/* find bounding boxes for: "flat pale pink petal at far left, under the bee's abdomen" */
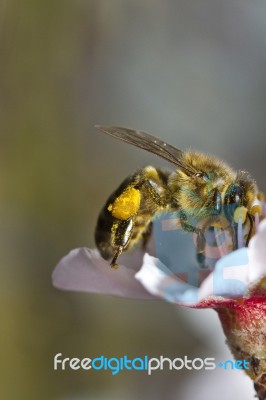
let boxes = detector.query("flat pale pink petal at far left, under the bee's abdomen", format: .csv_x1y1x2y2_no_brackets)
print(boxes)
52,247,154,299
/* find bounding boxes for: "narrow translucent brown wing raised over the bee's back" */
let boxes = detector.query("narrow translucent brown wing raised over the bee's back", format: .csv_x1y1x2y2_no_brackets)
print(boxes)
95,125,195,174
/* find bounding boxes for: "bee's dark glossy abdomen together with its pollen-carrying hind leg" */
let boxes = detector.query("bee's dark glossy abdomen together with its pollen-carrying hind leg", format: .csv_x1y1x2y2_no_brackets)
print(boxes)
95,166,169,265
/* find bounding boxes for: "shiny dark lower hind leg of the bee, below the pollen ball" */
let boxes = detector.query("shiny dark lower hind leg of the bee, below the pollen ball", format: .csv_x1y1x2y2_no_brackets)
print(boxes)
110,218,135,269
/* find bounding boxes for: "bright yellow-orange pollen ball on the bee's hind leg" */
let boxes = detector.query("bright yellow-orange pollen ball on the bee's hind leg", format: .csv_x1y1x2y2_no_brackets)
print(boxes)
108,188,141,220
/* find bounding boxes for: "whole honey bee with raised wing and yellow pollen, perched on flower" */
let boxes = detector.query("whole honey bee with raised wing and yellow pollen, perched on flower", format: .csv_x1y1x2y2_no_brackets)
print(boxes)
95,125,257,268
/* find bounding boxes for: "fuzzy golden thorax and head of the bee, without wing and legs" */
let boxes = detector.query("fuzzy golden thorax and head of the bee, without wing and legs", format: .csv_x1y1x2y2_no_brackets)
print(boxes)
172,151,256,218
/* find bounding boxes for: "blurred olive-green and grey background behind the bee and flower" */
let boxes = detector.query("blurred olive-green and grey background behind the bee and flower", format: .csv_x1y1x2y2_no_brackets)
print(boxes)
0,0,266,400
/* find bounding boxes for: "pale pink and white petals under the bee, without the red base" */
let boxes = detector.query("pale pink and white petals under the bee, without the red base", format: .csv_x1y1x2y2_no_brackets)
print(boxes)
52,216,266,308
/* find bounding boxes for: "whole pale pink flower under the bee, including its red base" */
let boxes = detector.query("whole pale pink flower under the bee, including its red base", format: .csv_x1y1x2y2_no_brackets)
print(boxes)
52,212,266,400
